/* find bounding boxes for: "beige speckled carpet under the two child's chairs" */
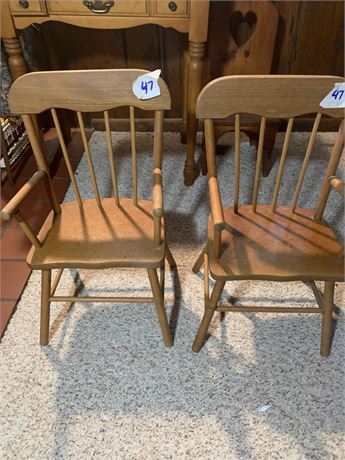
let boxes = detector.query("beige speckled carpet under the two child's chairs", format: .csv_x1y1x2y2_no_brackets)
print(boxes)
0,132,345,460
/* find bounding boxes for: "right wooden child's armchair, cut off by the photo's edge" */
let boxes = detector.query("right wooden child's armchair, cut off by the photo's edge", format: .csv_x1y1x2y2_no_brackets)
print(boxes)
193,76,344,356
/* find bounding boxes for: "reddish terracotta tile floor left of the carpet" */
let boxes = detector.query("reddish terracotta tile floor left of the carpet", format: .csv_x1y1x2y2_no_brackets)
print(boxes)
0,130,84,337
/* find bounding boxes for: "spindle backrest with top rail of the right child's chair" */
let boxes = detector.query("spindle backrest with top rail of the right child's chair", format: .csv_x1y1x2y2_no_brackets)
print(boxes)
196,75,344,220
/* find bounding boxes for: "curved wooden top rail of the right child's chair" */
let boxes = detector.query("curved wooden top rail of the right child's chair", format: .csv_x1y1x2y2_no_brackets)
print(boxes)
196,75,345,119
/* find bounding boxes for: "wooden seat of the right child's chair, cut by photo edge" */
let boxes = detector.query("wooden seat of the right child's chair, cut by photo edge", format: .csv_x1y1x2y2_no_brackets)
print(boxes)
208,205,344,281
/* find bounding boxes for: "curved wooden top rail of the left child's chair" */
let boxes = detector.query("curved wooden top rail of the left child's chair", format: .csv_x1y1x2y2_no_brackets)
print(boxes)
9,69,171,114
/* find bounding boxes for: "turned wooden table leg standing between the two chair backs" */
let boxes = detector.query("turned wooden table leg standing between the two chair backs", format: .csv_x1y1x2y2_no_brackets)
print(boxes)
184,41,205,185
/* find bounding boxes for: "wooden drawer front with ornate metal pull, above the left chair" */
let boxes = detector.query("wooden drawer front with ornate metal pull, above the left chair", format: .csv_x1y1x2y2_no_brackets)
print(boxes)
46,0,147,16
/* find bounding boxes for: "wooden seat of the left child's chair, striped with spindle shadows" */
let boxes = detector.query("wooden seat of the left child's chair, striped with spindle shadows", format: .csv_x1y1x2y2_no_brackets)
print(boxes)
27,198,164,270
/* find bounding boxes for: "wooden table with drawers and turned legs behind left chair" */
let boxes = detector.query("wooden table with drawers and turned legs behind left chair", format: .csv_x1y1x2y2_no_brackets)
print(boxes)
0,0,209,185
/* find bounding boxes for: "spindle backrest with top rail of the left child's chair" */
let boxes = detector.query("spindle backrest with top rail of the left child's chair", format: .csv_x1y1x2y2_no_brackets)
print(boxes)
9,69,171,211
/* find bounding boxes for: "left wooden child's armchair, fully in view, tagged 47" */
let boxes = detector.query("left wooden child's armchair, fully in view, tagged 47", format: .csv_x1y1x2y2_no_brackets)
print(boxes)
1,69,175,346
